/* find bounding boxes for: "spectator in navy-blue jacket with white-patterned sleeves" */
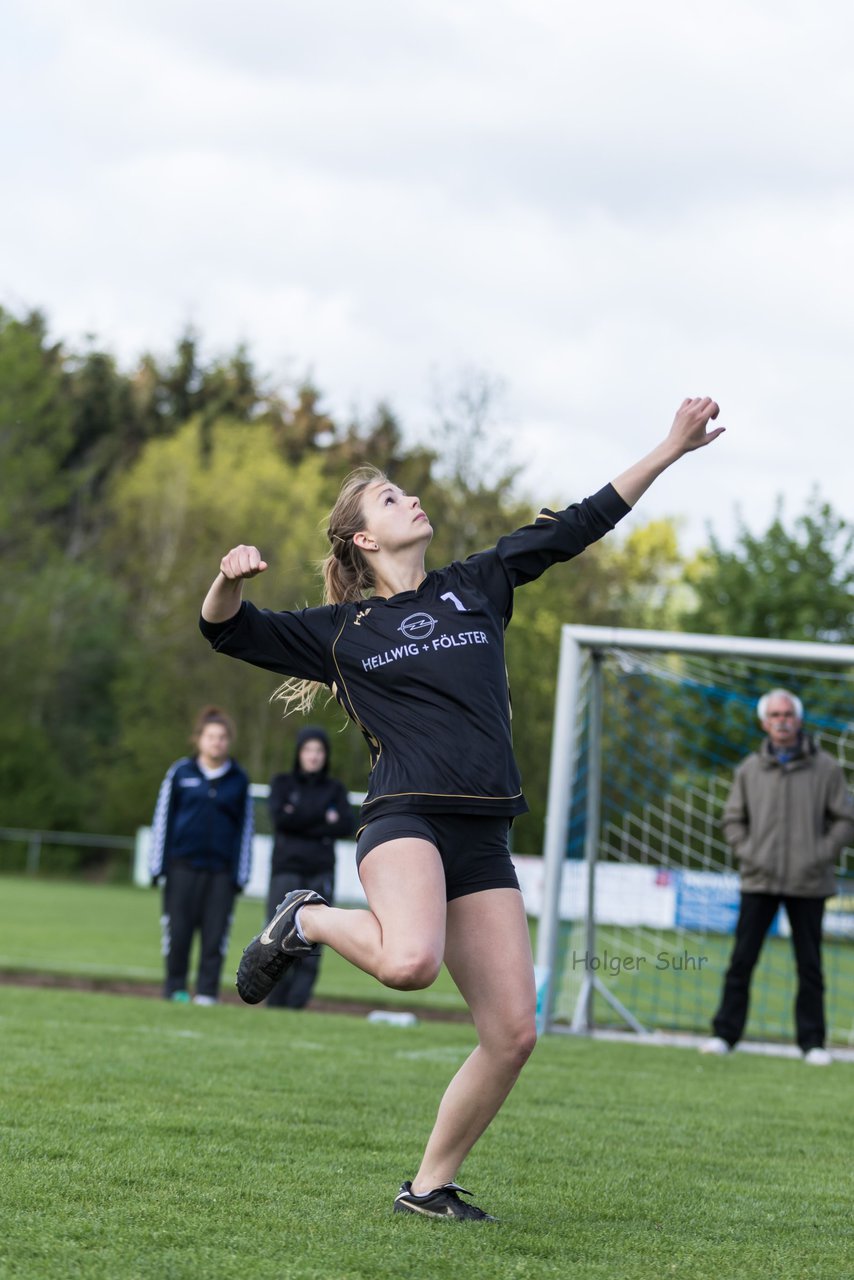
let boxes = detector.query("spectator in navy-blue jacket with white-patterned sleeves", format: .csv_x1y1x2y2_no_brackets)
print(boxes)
149,707,252,1005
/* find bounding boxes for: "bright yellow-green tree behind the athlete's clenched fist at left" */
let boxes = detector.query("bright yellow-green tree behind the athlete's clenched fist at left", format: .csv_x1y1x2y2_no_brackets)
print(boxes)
101,420,364,828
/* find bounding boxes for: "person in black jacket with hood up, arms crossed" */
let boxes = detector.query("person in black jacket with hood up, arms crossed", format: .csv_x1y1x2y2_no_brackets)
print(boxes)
266,727,355,1009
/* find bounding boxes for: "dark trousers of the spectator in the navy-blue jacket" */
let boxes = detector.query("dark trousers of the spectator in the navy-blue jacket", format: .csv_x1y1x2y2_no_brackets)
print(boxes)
160,861,237,998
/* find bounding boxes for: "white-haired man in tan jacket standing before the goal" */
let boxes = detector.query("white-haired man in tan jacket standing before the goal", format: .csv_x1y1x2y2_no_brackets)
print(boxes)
702,689,854,1066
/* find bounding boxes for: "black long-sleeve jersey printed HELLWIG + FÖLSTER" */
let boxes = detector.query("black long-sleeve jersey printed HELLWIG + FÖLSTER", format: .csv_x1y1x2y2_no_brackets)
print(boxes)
200,485,630,823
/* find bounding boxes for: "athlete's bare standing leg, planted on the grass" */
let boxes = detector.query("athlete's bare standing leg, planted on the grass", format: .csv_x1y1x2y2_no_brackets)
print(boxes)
412,888,536,1194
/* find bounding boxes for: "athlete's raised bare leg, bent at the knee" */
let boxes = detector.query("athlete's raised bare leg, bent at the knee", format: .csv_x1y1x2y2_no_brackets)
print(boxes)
300,837,446,991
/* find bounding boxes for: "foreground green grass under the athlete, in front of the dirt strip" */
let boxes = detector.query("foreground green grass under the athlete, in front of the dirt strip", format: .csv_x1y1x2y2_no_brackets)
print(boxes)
0,987,854,1280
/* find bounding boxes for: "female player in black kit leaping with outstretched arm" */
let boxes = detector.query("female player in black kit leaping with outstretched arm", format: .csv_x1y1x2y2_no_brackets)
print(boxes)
201,398,723,1220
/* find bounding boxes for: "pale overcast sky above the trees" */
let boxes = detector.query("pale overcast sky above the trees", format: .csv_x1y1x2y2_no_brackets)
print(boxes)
0,0,854,543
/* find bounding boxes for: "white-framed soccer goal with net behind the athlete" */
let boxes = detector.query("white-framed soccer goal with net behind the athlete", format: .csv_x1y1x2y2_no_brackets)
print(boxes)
536,626,854,1044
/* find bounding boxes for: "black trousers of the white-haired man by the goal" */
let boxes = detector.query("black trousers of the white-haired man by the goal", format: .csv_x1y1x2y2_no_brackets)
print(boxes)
712,893,825,1052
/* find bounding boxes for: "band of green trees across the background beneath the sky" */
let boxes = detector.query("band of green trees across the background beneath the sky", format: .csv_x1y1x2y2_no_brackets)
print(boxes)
0,310,854,870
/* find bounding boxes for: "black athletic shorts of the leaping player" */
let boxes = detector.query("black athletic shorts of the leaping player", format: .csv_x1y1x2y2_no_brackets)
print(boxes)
356,813,519,902
